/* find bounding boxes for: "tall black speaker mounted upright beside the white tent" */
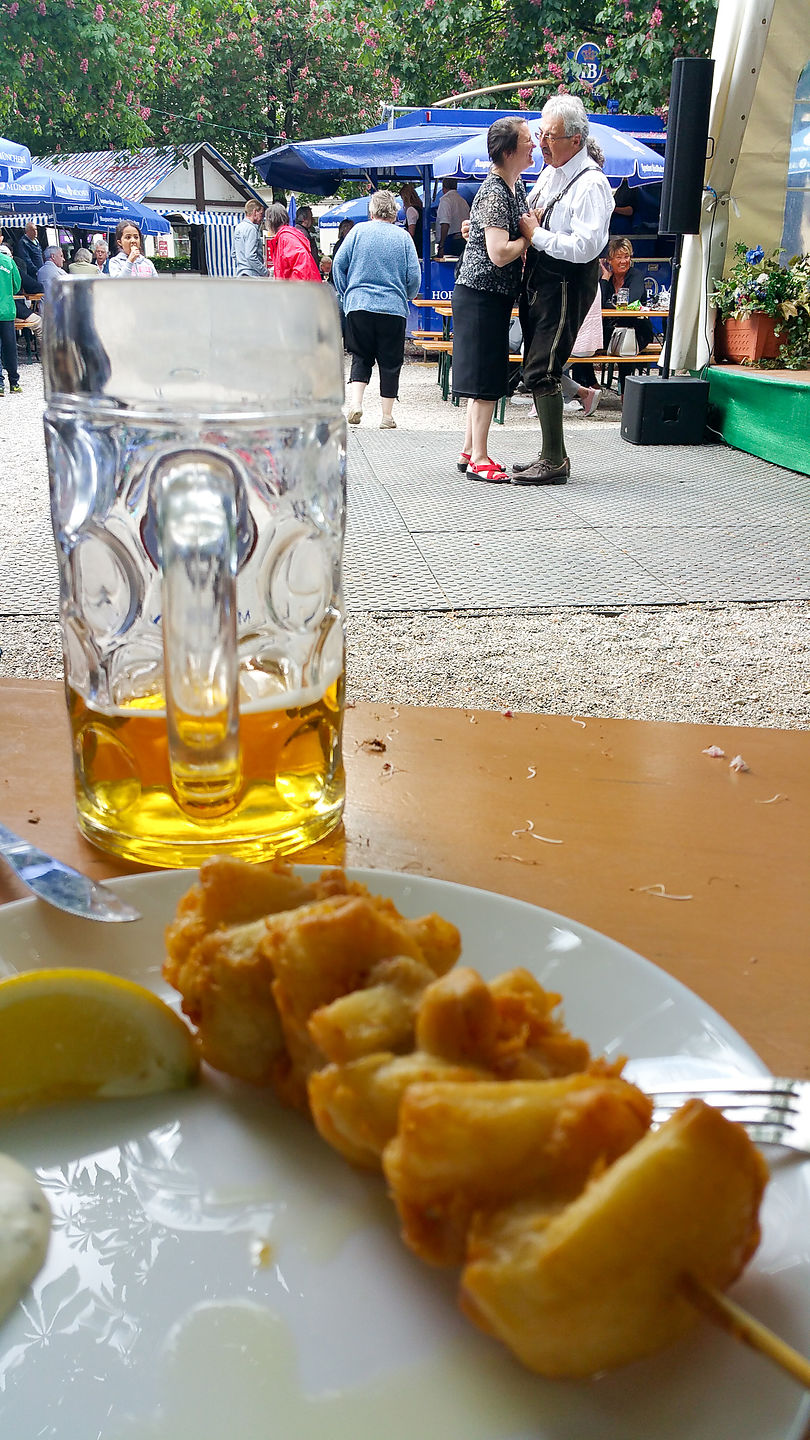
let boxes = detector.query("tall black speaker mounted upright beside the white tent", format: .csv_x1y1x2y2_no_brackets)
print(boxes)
659,59,715,235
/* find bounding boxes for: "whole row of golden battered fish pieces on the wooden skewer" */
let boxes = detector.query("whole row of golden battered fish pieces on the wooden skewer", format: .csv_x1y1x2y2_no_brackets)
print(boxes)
166,861,767,1377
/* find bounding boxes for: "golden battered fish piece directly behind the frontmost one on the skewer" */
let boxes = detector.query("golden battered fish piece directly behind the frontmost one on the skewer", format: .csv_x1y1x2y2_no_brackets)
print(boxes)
382,1073,653,1264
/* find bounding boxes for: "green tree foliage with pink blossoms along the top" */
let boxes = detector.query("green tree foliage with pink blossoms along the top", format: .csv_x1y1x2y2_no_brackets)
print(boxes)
0,0,715,173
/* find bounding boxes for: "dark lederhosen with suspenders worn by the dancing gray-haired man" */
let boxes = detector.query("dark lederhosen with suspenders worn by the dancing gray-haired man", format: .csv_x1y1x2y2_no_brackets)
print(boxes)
517,166,600,395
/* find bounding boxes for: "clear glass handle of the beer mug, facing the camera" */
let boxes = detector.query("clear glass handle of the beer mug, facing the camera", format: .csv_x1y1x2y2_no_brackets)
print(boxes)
153,446,242,821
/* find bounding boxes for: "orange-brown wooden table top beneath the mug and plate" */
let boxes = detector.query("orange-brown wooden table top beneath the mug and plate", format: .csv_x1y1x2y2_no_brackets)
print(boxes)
0,680,810,1076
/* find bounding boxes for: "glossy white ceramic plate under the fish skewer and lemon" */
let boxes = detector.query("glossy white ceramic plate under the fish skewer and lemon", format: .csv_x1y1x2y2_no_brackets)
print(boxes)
0,871,810,1440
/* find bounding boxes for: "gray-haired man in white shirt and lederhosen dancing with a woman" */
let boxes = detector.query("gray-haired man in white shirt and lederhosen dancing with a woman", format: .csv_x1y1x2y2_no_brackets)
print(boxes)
512,95,613,485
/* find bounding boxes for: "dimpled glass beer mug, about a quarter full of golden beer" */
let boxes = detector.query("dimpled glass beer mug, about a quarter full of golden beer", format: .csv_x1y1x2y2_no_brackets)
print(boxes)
45,278,346,865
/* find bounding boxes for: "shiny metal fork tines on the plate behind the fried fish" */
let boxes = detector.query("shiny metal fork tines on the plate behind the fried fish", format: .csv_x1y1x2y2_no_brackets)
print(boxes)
647,1076,810,1155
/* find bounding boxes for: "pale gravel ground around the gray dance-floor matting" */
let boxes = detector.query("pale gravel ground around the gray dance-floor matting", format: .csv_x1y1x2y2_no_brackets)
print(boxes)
0,349,810,729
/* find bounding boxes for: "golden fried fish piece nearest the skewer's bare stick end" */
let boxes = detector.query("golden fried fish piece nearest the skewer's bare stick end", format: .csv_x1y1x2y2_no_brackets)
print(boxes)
461,1100,768,1378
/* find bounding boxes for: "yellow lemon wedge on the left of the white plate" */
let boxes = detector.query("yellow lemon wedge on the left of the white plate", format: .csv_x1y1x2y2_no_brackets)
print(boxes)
0,969,199,1110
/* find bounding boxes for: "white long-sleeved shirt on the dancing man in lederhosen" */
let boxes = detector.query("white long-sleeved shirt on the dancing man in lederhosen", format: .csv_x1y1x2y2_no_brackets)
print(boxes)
529,150,613,265
